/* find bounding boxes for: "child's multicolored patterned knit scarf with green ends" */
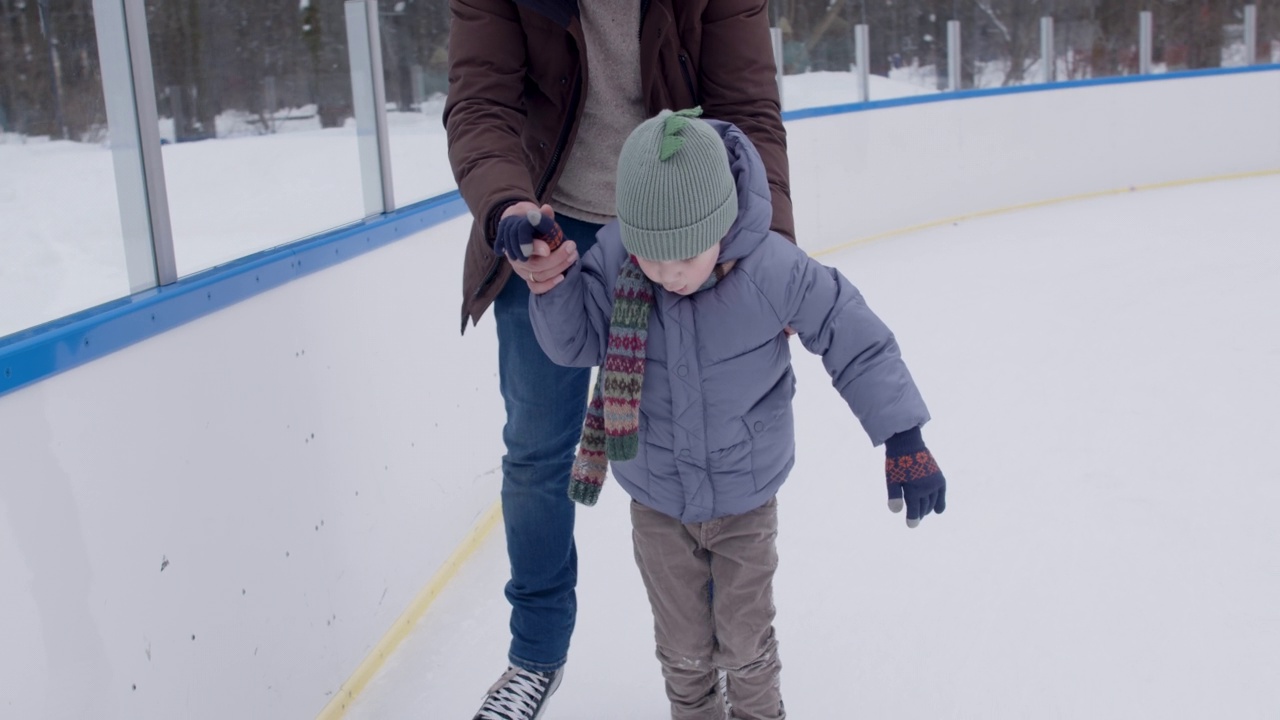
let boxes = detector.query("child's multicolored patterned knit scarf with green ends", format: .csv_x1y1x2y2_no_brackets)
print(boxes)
568,258,733,505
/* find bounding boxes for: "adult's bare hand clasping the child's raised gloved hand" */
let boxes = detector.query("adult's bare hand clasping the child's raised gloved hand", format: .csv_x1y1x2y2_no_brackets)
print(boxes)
493,201,577,295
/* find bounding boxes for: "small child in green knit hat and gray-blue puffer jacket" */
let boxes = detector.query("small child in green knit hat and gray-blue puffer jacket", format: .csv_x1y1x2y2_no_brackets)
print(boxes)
497,109,946,720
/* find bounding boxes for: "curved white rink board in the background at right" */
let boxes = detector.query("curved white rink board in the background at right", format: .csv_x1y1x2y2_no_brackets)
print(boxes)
787,72,1280,250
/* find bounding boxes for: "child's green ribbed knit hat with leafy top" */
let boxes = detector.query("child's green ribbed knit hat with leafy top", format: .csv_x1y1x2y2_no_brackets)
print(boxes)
617,108,737,261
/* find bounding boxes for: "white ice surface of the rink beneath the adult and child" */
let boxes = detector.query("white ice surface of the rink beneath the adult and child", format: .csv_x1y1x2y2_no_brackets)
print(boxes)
347,176,1280,720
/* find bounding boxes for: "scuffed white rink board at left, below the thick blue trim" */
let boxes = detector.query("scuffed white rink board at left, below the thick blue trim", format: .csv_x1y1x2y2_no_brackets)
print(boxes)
0,212,503,720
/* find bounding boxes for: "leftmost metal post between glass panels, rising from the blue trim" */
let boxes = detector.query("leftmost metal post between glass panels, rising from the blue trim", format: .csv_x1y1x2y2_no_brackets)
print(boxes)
93,0,178,292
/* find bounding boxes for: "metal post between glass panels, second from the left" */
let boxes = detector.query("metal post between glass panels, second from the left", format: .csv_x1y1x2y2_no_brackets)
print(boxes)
344,0,396,217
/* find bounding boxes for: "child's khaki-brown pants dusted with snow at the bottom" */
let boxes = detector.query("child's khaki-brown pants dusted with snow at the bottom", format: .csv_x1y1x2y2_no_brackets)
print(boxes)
631,500,786,720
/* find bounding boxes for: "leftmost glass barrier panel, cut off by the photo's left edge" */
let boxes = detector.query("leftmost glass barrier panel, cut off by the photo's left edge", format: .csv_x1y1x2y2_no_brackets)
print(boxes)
0,0,129,337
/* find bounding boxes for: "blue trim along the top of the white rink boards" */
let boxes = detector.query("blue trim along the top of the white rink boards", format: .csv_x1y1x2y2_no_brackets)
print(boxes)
0,64,1280,396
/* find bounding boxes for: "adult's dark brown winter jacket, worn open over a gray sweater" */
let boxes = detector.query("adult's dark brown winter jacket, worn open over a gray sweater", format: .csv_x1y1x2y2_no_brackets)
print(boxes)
444,0,795,331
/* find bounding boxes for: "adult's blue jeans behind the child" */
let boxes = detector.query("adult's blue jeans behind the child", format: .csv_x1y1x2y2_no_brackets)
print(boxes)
493,211,600,671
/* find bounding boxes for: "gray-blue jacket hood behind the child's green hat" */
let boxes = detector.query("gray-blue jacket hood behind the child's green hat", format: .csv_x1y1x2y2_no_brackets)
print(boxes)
704,118,773,263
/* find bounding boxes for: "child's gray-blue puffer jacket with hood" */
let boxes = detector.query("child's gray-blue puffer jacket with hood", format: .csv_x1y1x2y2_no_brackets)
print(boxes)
529,120,929,523
